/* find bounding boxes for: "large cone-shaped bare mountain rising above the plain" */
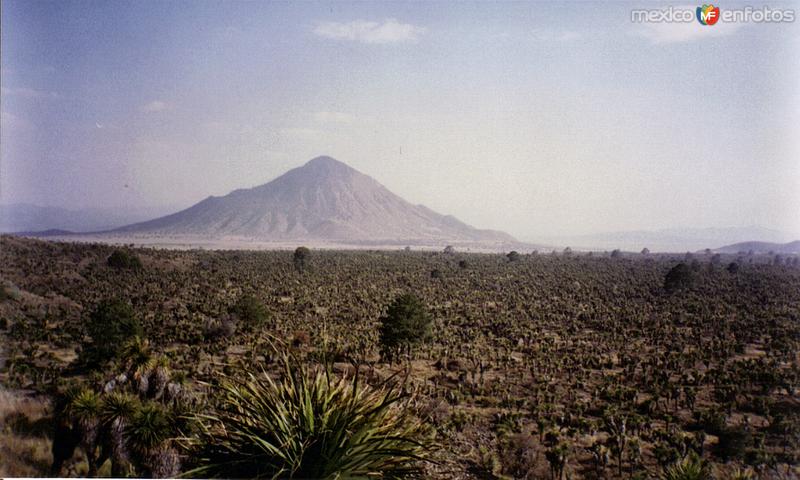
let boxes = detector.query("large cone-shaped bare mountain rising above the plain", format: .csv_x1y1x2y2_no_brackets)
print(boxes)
108,156,515,244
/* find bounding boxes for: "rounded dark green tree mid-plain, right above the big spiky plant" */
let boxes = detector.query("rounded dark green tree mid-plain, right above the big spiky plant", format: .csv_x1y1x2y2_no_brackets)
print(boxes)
380,293,431,361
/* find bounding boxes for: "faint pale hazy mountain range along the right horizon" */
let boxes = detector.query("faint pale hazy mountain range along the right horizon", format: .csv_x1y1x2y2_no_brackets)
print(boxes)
547,226,793,252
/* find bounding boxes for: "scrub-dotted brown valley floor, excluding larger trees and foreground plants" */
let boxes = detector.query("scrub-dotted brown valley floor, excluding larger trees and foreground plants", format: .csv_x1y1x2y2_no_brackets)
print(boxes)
0,236,800,479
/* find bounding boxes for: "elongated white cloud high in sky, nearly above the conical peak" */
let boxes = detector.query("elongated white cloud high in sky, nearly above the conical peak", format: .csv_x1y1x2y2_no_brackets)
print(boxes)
314,18,425,44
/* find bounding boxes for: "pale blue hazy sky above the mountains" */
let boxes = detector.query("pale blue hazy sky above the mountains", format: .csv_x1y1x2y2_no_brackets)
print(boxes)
0,0,800,239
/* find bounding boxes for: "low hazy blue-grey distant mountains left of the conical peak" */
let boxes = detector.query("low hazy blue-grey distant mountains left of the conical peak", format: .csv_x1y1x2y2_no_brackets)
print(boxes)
0,203,176,233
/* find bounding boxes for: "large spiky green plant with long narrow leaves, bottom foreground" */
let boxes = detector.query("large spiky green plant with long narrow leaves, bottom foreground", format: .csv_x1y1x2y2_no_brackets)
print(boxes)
187,358,431,478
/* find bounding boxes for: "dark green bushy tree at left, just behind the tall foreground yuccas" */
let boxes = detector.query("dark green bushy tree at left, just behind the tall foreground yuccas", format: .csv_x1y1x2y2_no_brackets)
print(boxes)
83,299,142,364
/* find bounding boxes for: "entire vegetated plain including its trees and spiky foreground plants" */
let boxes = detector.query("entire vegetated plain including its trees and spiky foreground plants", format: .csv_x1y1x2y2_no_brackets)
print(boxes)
0,237,800,479
